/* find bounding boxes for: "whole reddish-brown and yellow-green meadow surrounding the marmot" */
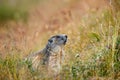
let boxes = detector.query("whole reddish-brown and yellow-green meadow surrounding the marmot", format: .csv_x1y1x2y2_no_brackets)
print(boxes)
0,0,120,80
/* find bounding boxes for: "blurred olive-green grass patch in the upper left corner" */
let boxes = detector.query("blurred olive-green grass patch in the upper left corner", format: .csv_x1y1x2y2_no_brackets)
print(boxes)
0,0,42,22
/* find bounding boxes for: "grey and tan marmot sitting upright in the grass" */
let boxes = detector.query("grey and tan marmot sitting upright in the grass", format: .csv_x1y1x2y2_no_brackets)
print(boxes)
27,34,67,75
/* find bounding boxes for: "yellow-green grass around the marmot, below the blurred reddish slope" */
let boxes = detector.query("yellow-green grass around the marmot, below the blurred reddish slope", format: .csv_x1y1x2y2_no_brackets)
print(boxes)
0,0,120,80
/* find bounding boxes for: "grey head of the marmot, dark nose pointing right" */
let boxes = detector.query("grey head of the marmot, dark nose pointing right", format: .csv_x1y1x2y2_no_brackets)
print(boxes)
47,34,67,49
